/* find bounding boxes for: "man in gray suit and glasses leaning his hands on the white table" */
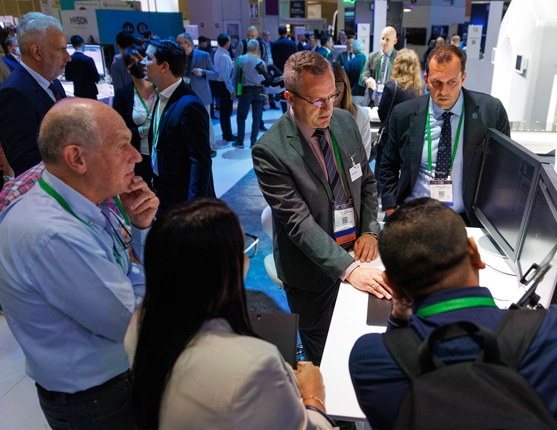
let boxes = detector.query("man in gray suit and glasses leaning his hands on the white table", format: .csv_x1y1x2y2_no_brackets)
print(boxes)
252,51,391,365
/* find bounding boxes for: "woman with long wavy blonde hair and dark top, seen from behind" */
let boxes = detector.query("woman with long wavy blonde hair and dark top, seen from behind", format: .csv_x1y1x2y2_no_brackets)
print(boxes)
375,48,424,187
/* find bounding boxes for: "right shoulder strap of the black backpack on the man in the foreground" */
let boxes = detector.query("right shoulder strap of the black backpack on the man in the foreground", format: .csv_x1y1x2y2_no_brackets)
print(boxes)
495,309,545,370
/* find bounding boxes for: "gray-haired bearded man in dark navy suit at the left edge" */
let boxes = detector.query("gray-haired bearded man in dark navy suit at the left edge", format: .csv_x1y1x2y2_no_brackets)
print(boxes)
0,12,71,176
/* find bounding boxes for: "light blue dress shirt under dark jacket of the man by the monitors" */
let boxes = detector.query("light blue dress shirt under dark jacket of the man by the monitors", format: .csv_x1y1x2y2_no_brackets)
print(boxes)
405,90,464,213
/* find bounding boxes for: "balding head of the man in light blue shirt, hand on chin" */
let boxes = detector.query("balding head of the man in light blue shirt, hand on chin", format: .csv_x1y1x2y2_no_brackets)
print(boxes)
39,98,141,204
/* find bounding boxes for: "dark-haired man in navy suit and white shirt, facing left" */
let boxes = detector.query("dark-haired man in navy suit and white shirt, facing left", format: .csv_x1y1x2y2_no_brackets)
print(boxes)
143,40,215,210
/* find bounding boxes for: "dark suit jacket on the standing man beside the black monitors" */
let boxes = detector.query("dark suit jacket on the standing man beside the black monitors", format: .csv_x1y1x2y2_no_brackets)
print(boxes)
379,88,510,226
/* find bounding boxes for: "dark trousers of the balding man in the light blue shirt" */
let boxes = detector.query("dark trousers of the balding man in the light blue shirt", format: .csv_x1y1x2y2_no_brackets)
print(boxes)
35,371,137,430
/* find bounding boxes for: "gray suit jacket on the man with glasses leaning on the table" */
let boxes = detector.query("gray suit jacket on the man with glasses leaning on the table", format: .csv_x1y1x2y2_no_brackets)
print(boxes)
252,108,379,292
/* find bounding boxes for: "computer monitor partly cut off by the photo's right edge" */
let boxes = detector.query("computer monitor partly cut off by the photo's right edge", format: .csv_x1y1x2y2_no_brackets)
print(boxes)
517,163,557,308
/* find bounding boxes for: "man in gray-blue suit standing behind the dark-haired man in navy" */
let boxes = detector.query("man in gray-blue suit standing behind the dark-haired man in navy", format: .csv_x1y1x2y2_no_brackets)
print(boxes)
176,33,219,157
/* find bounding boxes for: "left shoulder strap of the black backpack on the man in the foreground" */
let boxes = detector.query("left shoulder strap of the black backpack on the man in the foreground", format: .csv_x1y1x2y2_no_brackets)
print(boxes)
381,327,422,379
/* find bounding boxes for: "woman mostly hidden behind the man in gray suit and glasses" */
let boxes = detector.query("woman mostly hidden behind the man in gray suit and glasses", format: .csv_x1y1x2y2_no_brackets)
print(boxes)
333,63,371,161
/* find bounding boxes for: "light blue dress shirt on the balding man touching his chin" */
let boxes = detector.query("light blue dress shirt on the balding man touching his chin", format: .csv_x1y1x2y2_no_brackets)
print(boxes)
0,170,147,393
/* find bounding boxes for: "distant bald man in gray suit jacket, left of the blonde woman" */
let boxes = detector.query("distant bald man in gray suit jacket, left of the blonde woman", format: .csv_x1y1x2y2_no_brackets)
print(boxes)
362,27,397,107
